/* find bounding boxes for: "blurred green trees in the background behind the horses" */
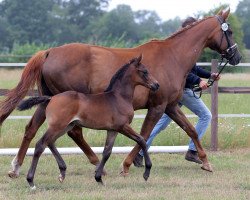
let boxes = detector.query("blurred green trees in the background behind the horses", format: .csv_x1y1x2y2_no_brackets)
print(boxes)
0,0,250,62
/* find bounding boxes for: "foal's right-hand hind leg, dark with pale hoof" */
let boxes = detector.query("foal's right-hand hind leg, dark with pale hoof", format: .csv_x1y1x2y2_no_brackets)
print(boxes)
48,143,67,183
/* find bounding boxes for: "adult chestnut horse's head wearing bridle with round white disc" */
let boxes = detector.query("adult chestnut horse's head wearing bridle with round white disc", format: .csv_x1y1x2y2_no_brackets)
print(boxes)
207,9,241,65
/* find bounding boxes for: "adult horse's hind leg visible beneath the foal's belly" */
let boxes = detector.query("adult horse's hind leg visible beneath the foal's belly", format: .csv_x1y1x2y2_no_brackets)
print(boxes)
68,126,100,166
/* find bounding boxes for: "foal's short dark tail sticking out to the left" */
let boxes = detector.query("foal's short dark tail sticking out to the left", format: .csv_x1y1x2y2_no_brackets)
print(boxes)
17,96,51,111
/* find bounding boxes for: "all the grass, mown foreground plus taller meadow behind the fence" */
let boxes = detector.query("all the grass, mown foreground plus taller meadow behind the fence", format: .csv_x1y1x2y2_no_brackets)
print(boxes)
0,69,250,200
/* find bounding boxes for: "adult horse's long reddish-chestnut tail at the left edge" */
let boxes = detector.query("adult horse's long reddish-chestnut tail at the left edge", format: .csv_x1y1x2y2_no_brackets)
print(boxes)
0,51,49,125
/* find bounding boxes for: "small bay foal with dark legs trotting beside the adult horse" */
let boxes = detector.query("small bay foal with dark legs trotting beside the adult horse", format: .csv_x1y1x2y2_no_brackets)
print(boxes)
18,56,159,189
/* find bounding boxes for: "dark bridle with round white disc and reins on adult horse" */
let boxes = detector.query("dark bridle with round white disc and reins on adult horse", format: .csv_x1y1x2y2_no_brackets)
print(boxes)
192,15,234,99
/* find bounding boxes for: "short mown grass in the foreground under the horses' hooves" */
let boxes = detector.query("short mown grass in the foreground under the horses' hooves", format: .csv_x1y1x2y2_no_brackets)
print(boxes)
0,148,250,200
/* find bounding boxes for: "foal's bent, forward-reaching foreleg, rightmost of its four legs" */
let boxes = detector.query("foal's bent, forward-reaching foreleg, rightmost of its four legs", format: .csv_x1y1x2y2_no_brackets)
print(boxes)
121,124,152,180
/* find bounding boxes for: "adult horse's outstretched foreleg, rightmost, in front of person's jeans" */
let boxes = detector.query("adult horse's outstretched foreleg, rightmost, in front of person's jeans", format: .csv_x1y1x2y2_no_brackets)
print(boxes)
165,106,213,172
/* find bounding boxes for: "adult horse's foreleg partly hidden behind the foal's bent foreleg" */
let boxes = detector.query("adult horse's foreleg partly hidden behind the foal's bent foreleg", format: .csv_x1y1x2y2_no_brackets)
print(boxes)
121,105,165,175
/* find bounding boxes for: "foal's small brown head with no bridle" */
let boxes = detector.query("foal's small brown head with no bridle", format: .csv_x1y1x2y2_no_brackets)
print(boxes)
131,55,160,91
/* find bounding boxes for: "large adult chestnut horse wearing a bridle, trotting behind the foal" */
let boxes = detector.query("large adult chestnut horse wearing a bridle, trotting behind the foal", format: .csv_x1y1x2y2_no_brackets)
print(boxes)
0,9,241,177
